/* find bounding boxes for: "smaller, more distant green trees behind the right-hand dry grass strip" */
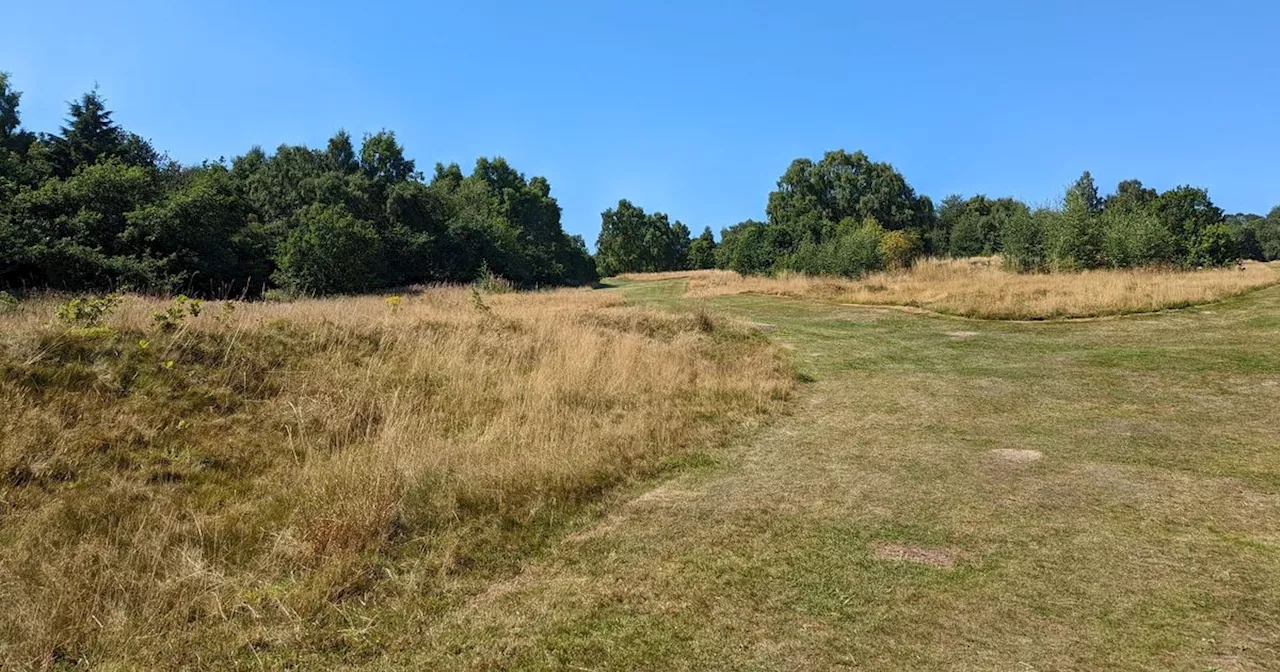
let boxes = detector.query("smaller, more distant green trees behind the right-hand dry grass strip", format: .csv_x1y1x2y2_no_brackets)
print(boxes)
596,150,1280,276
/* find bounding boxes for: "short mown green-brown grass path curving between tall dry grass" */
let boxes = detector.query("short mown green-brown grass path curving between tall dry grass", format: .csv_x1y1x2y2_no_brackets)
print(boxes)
378,276,1280,671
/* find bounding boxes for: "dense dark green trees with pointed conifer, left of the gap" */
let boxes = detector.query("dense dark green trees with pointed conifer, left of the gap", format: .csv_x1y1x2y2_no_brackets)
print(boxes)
0,73,598,296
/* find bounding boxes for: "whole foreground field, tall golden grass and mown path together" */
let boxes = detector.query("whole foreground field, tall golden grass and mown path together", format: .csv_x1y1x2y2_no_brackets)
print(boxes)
0,269,1280,672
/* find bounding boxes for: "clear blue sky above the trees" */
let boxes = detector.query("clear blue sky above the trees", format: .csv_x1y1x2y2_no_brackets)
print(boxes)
0,0,1280,243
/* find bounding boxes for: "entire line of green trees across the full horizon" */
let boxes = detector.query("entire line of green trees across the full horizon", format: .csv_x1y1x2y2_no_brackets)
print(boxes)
0,73,1280,296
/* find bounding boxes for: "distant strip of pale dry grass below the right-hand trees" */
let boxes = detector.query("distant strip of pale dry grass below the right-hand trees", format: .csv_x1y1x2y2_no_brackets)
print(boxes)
623,257,1280,320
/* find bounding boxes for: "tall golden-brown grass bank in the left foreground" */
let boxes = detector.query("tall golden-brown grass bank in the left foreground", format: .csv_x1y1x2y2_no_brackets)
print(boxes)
0,288,792,667
